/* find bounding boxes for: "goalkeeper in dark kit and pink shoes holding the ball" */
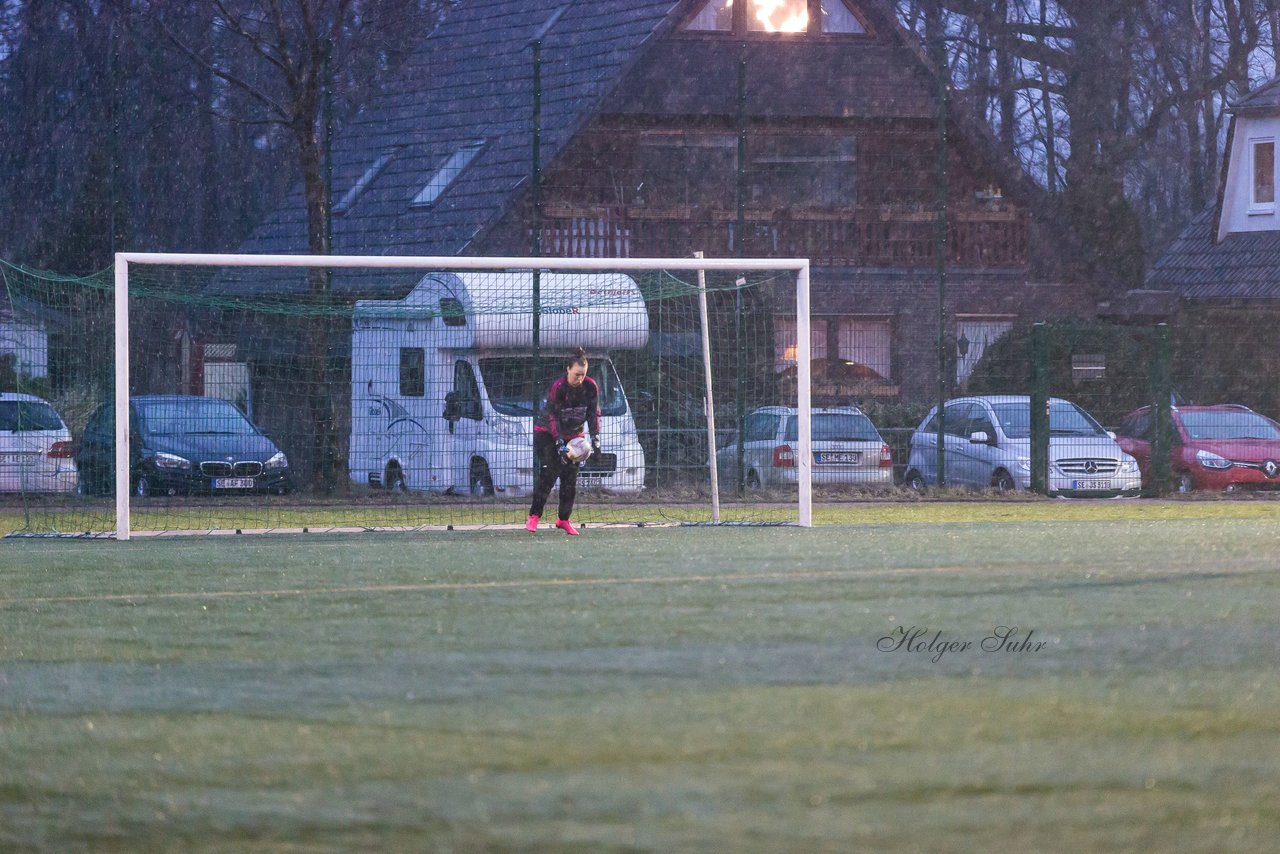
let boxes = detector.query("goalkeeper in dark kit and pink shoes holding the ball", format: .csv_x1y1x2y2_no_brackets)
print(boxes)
525,347,600,536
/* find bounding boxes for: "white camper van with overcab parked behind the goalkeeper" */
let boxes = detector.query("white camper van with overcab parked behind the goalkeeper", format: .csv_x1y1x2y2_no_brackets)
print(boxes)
348,270,649,497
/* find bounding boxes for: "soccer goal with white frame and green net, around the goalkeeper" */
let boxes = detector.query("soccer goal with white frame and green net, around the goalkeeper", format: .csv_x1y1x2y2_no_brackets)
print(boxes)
2,252,812,539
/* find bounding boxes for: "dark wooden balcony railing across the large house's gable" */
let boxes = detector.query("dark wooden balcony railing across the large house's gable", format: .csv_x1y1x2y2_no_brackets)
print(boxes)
541,205,1027,266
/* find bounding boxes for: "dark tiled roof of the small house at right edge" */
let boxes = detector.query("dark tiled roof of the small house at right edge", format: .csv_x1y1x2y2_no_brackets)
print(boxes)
1146,206,1280,300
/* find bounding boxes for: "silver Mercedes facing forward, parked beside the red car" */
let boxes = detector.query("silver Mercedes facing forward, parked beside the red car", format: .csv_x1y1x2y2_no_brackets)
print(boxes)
904,394,1142,498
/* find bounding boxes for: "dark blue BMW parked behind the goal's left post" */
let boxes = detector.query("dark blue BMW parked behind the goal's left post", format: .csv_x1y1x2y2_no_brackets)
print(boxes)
76,394,291,497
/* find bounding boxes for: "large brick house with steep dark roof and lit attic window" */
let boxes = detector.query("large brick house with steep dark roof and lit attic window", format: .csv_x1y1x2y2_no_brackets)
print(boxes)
218,0,1098,417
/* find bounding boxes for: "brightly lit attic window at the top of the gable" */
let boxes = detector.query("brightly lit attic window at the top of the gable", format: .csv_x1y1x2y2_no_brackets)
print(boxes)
685,0,868,36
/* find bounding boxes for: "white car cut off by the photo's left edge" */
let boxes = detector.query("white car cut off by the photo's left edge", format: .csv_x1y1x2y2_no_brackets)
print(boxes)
0,392,77,493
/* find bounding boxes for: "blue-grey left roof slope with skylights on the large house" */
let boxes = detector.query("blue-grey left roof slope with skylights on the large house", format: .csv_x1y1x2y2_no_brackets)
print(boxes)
214,0,678,293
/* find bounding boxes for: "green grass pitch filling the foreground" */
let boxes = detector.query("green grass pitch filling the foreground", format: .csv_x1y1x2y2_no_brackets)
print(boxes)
0,502,1280,853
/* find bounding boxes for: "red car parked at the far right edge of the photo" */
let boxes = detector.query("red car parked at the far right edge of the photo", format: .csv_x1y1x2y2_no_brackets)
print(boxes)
1116,403,1280,492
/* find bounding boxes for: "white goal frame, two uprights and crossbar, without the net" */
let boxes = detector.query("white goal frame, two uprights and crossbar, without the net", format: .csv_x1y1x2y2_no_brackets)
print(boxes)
114,252,813,540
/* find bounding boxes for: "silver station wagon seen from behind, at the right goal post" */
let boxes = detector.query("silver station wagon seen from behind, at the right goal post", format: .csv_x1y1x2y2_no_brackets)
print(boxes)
716,406,893,488
